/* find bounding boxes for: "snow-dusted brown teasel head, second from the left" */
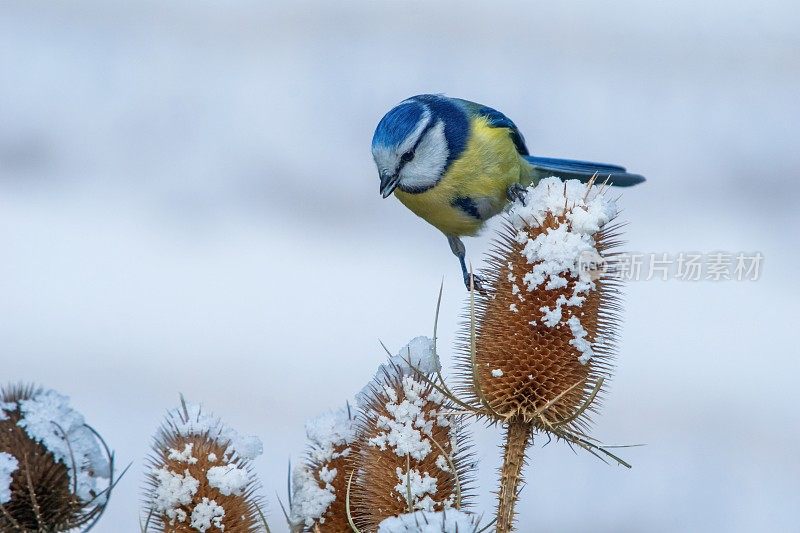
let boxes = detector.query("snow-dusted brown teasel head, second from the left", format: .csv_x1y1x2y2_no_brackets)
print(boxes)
143,399,266,533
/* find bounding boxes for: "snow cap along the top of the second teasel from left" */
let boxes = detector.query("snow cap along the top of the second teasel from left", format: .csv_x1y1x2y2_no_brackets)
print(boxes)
168,403,264,461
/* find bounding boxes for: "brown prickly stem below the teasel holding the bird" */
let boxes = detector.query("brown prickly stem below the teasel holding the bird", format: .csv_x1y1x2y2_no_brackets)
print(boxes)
496,418,533,533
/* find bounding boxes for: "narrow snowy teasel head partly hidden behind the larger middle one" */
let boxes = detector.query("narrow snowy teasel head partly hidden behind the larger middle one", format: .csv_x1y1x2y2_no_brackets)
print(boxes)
290,405,358,533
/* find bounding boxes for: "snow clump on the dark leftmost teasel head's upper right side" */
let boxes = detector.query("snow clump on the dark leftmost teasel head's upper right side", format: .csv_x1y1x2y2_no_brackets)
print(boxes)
17,390,110,502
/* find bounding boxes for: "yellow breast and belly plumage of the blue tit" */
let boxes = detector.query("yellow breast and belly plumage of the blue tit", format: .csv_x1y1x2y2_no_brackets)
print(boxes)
395,117,526,236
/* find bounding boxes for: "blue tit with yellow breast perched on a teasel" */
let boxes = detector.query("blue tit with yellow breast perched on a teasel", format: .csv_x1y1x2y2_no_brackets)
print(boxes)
372,94,645,290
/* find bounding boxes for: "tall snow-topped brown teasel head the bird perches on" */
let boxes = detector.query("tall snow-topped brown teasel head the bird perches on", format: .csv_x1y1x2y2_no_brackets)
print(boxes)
461,178,619,431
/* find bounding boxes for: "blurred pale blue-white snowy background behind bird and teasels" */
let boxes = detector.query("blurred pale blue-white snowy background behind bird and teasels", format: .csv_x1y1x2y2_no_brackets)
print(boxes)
0,0,800,532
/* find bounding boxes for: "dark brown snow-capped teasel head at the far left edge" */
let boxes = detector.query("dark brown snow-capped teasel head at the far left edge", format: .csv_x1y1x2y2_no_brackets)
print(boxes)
0,385,114,531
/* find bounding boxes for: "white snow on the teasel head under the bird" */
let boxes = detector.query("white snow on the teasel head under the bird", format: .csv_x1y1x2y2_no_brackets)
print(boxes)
509,177,618,364
